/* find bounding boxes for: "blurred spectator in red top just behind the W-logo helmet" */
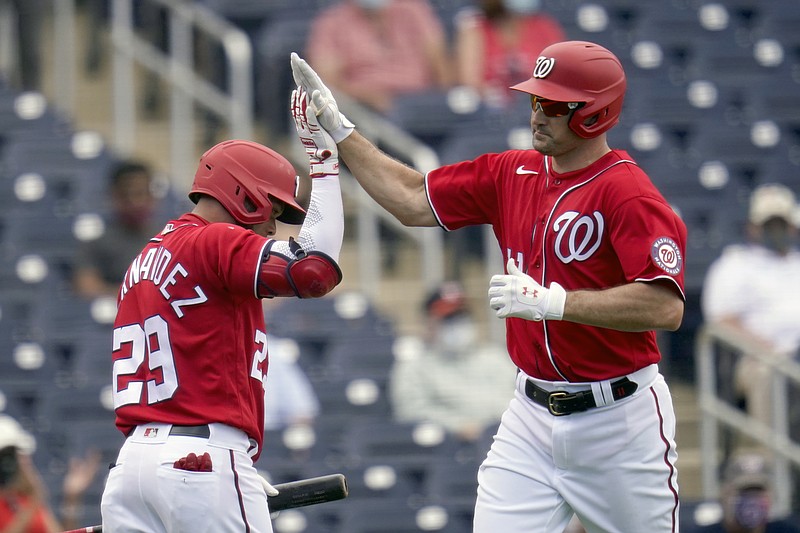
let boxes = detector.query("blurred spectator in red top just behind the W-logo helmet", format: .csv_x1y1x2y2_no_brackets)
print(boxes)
454,0,565,107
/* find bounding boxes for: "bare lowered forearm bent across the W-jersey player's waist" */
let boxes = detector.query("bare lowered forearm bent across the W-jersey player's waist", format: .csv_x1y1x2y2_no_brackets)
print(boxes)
563,282,684,331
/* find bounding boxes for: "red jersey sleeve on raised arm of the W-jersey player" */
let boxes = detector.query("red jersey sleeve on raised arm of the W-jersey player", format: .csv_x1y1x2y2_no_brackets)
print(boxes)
425,154,500,231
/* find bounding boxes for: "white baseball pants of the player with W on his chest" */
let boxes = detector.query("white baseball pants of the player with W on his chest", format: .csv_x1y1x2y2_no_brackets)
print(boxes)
473,365,679,533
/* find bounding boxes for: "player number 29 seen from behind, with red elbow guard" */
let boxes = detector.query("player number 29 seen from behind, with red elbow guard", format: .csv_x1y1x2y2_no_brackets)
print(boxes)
102,90,344,533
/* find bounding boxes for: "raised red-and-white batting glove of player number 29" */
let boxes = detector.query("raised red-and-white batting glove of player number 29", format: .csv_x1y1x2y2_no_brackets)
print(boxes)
291,87,339,178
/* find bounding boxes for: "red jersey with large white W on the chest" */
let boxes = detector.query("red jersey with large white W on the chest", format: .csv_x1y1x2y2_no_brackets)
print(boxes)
426,150,686,382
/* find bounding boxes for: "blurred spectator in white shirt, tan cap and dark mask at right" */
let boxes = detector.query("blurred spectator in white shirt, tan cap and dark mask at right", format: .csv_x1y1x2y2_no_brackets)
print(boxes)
702,184,800,424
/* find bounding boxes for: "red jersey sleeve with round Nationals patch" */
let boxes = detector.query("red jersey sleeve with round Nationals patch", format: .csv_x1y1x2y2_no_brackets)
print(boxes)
610,196,686,298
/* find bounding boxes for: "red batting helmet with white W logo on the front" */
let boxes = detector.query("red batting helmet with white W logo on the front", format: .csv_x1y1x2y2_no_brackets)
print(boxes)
511,41,626,139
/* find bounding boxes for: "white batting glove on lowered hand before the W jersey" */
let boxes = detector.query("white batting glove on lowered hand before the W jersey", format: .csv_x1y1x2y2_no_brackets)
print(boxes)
489,259,567,322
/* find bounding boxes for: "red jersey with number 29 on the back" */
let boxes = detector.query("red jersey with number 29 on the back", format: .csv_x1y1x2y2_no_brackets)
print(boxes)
113,214,269,458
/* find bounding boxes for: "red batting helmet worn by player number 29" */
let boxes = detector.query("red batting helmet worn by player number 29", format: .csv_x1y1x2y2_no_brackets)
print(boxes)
189,140,306,225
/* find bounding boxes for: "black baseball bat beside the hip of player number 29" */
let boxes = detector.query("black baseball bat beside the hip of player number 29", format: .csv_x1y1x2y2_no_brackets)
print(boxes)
63,474,349,533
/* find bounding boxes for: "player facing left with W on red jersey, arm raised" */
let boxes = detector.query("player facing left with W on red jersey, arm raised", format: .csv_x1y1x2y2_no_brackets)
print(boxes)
291,41,686,533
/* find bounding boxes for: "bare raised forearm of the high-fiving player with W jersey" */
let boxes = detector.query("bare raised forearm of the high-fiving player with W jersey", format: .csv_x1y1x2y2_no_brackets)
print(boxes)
338,131,437,226
